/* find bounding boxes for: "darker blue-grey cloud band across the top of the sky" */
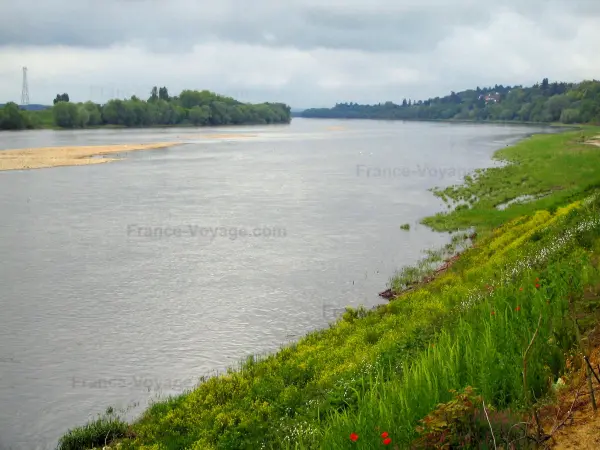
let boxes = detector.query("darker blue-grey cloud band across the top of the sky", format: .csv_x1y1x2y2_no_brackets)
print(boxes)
0,0,600,52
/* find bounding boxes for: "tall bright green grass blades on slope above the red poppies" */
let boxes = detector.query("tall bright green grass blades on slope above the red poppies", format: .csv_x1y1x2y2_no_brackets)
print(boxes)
308,253,599,449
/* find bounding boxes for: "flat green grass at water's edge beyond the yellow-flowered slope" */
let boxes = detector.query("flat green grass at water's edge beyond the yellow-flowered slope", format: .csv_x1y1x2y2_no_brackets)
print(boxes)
422,127,600,231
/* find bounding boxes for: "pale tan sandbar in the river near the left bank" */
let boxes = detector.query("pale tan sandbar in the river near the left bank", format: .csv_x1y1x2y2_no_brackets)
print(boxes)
0,142,182,170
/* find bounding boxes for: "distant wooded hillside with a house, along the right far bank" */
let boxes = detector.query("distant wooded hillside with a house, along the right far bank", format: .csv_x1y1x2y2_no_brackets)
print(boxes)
298,78,600,124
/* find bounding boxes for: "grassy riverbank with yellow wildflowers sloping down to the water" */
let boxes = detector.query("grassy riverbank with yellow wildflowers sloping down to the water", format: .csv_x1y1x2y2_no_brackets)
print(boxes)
60,128,600,450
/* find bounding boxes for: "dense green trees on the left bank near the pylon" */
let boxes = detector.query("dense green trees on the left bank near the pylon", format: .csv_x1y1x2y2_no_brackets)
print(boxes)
0,87,291,130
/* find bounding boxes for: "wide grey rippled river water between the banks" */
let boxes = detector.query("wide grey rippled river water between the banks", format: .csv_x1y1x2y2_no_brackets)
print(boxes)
0,119,542,450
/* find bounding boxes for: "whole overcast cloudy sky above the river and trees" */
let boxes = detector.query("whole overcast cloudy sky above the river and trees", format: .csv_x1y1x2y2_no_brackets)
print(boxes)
0,0,600,108
